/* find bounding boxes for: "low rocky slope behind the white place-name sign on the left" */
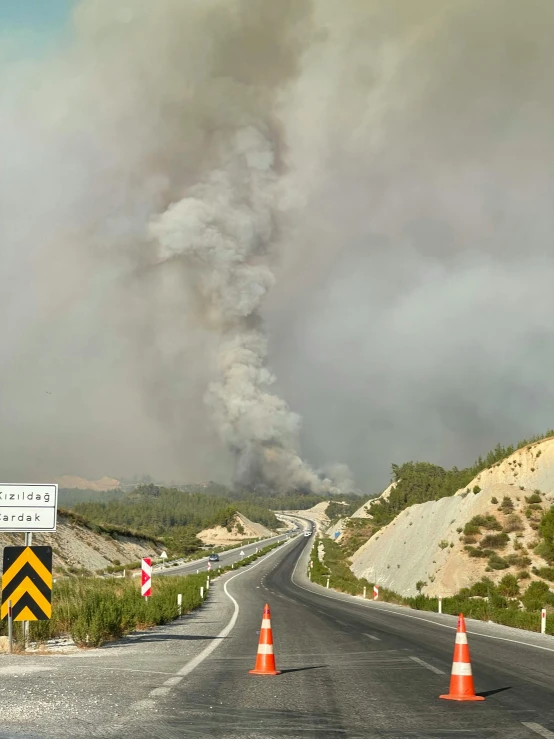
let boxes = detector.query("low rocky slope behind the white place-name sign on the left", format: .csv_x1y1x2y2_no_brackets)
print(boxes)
0,513,162,574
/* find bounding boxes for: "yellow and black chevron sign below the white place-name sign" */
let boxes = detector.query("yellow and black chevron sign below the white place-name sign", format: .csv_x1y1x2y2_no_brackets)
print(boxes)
0,547,52,621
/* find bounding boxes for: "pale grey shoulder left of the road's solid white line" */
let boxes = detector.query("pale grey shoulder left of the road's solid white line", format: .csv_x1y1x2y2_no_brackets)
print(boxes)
0,568,235,739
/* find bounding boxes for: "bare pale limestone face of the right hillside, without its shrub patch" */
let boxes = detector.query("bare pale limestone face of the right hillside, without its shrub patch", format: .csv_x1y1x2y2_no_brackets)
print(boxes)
352,438,554,596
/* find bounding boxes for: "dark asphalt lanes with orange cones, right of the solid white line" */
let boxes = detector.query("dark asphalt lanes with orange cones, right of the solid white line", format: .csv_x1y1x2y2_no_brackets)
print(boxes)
137,537,554,739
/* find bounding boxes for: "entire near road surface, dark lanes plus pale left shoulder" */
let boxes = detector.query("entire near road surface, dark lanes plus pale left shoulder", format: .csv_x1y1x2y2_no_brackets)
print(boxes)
0,536,554,739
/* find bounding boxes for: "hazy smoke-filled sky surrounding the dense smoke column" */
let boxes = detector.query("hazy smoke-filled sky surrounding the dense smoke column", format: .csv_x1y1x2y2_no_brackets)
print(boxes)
0,0,554,492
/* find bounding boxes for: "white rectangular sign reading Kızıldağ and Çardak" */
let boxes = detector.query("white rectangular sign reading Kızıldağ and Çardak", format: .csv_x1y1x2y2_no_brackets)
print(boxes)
0,483,58,531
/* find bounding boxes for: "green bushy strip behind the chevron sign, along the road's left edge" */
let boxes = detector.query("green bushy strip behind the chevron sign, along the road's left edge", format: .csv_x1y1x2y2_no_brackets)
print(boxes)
0,542,283,647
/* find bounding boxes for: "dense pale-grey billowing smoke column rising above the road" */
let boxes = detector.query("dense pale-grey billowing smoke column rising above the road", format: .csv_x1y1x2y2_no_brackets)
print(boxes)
150,126,330,491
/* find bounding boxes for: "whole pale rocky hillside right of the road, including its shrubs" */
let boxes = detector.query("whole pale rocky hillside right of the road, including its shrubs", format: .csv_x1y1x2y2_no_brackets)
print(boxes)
352,438,554,596
